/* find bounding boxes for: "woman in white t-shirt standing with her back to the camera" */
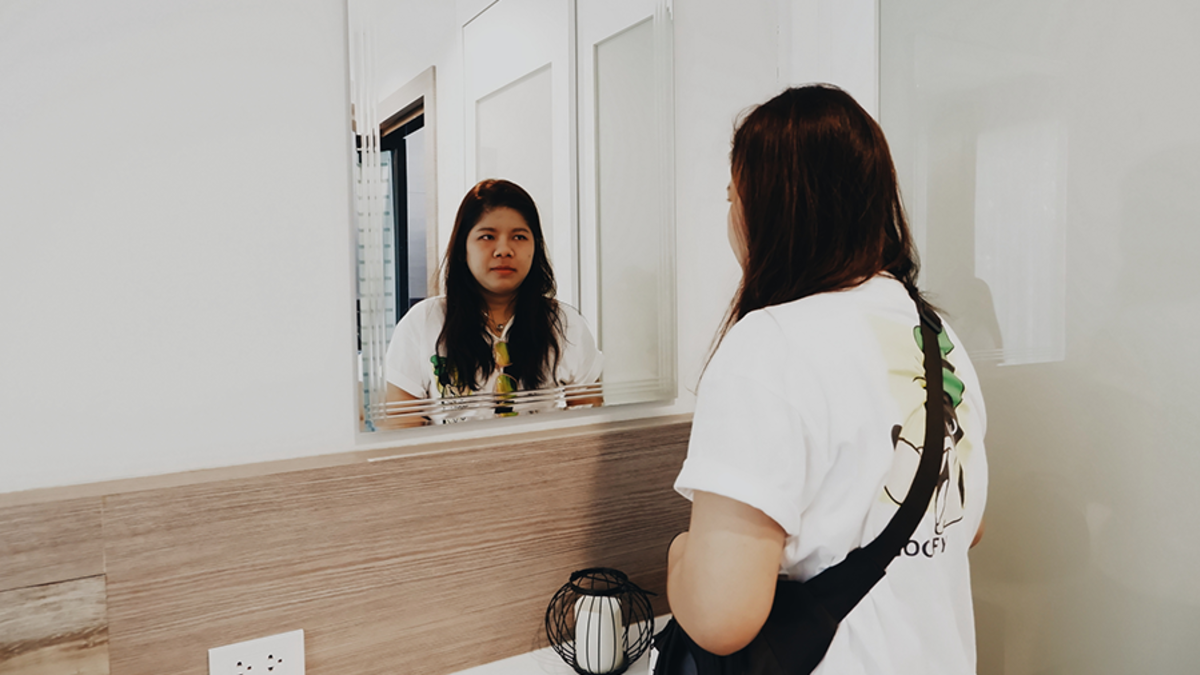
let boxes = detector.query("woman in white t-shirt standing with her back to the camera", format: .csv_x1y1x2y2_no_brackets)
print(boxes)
667,85,988,675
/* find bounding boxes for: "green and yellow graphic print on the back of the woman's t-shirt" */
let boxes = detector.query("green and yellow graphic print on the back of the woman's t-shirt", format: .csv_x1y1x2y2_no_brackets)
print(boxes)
883,325,966,536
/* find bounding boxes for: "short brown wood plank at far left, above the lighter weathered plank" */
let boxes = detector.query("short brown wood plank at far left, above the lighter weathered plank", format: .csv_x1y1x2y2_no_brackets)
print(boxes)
0,497,104,591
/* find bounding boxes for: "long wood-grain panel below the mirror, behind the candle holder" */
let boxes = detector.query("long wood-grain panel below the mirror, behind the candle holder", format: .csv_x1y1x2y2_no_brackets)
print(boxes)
0,422,690,675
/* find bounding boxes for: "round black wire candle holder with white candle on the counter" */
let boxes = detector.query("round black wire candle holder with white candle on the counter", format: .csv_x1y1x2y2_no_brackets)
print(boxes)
546,567,654,675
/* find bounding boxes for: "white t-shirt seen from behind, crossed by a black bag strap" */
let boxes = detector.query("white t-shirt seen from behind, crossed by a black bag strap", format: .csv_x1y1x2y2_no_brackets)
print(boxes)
676,276,988,675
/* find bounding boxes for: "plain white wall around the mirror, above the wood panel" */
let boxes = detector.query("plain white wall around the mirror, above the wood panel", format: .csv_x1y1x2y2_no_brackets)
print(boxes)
0,0,874,494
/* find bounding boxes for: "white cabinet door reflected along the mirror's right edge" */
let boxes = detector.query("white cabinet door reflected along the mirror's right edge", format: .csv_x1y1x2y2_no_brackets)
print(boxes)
577,0,674,402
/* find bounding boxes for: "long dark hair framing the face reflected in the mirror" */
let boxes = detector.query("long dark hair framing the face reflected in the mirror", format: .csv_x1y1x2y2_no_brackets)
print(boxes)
438,179,563,390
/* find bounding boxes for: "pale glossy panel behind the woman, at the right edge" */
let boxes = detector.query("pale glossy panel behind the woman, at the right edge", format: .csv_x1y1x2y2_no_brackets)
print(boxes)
880,0,1200,675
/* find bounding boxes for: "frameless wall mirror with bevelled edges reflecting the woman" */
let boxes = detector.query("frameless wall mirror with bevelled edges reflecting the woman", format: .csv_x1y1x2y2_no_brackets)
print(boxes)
349,0,676,431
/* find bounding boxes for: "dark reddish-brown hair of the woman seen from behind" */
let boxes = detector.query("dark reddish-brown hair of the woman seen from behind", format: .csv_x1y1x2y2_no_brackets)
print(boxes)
716,84,924,342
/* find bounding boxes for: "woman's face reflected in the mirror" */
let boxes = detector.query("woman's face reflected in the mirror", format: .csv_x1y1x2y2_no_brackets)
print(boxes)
467,207,535,298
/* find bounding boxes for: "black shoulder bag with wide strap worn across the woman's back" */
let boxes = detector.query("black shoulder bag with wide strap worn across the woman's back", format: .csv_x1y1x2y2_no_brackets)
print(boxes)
653,301,946,675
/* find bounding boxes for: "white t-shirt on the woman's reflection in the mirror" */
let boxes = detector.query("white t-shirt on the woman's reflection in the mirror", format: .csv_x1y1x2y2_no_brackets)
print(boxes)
386,295,604,423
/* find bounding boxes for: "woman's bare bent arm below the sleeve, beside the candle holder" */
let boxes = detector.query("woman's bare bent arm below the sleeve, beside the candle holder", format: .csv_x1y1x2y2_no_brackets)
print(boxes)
667,491,787,655
